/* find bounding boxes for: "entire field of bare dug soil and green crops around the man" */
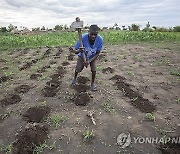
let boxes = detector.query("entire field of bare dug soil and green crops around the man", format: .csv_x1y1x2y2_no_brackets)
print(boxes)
0,31,180,154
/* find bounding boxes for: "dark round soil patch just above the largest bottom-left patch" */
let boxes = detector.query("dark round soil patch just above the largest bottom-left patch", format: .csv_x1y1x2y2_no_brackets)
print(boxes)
23,106,51,122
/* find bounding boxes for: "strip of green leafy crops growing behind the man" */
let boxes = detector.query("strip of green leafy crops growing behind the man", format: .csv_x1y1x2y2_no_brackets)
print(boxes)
0,30,180,50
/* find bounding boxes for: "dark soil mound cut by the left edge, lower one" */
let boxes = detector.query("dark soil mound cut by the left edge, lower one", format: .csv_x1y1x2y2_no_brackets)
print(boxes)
0,94,21,106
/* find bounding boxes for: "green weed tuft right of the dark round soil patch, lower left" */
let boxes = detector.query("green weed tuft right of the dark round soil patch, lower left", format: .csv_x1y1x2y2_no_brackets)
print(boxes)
47,114,67,128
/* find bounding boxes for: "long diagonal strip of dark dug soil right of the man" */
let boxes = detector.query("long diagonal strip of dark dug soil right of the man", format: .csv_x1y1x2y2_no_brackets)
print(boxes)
110,76,156,113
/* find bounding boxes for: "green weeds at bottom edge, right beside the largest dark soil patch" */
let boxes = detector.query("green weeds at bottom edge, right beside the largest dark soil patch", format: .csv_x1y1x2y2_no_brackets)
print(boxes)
33,142,56,154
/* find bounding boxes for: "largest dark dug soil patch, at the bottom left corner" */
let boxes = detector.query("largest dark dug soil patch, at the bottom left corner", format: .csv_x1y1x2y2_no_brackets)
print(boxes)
13,123,49,154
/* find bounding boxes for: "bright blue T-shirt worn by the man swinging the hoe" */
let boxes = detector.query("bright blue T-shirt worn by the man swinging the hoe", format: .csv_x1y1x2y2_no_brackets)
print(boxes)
75,33,103,60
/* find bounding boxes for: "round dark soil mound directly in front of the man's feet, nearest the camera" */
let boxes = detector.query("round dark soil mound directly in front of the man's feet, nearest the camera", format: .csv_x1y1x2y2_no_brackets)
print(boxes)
72,93,90,106
